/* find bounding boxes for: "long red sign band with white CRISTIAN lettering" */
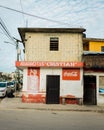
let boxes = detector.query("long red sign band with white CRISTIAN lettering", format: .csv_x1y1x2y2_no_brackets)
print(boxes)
16,61,83,68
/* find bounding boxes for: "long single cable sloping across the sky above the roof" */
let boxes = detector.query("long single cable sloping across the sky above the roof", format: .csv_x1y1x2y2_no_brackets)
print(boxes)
0,5,70,25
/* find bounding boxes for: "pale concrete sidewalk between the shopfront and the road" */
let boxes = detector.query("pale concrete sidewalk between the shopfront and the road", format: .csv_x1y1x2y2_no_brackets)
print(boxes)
0,97,104,113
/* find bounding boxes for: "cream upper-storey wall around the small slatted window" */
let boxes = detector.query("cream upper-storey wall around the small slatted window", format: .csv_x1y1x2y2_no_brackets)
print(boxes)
25,33,82,61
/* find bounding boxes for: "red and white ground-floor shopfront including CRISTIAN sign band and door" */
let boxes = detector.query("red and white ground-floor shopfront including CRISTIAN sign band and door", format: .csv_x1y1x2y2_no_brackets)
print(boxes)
16,61,83,104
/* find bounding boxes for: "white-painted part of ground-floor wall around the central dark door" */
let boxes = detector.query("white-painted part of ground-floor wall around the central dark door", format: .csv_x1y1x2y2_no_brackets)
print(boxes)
22,68,83,98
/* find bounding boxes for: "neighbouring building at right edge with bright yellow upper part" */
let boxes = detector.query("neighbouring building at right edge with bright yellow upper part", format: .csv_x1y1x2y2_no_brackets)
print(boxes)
83,38,104,105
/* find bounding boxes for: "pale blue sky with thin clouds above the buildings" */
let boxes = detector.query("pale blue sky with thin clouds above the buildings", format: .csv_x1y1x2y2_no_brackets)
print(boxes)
0,0,104,72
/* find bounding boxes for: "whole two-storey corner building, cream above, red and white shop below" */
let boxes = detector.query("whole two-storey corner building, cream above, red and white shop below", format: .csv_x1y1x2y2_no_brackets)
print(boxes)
16,28,85,104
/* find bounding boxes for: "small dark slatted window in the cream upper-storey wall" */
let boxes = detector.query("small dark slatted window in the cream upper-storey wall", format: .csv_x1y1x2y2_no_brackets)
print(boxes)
50,37,59,51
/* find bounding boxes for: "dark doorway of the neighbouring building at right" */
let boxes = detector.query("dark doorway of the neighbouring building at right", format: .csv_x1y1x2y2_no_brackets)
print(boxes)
84,75,97,105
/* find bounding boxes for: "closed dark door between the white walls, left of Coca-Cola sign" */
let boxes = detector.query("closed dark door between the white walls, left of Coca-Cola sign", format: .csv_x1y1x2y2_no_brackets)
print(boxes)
46,75,60,104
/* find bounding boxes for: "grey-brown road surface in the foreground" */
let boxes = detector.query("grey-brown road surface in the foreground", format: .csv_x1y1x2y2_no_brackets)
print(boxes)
0,109,104,130
